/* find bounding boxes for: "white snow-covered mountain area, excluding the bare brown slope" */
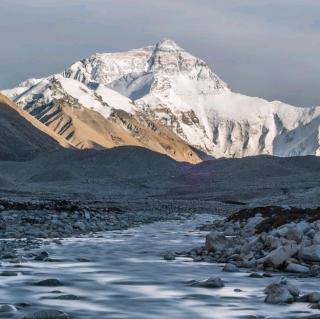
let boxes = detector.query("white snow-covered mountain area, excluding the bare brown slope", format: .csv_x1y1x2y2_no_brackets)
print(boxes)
4,39,320,157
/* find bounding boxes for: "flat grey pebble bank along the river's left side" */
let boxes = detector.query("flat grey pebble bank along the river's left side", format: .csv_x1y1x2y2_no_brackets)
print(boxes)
0,199,236,262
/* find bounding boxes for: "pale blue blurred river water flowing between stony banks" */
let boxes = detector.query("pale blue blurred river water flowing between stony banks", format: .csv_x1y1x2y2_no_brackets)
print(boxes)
0,215,320,319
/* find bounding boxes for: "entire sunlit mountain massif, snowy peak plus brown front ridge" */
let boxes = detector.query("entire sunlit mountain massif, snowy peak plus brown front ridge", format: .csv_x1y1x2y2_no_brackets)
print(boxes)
4,39,320,162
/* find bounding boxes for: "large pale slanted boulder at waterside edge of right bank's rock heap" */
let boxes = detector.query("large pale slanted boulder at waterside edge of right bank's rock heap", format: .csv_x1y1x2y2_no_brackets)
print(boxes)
258,244,300,268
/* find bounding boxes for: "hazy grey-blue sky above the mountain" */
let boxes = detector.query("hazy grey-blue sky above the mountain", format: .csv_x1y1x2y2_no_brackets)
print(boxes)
0,0,320,106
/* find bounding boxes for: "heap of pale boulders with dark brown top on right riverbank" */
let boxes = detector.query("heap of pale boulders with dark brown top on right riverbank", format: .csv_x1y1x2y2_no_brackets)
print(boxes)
184,206,320,277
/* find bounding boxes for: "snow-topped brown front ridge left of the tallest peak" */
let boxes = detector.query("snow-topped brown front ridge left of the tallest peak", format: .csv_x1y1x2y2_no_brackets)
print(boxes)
5,74,200,163
